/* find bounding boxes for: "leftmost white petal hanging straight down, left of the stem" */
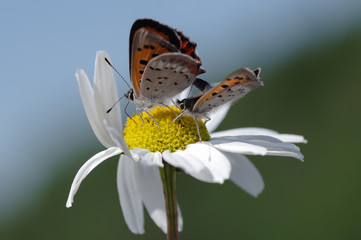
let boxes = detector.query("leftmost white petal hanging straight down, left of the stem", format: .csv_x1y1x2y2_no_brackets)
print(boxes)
117,155,144,234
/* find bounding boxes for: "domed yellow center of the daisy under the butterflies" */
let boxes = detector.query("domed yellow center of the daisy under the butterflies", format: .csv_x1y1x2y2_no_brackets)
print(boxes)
124,106,210,152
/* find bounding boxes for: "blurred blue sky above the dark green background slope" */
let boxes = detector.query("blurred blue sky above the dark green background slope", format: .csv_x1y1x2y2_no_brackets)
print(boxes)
0,0,361,232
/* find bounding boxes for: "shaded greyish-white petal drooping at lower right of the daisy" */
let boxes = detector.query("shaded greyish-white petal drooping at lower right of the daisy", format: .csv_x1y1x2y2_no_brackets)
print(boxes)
224,153,264,197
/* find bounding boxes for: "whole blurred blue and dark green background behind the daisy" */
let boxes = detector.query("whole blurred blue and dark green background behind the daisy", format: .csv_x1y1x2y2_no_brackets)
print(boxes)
0,0,361,239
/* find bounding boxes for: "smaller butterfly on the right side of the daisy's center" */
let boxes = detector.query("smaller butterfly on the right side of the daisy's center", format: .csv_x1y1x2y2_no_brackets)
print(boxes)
173,68,263,140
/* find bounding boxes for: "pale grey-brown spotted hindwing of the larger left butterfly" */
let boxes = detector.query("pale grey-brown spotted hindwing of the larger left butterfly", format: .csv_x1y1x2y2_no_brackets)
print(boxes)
140,53,201,103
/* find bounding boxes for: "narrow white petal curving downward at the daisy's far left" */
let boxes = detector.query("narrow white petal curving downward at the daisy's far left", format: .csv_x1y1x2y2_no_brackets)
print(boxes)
66,147,122,208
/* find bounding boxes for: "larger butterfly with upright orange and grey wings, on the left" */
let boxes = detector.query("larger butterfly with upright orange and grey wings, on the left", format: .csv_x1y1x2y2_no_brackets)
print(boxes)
125,19,205,123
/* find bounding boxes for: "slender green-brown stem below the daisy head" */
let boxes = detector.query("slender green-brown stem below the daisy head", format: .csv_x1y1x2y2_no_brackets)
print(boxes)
160,162,179,240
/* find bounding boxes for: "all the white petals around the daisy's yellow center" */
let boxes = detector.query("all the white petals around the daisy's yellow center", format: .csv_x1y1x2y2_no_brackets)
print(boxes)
66,52,306,233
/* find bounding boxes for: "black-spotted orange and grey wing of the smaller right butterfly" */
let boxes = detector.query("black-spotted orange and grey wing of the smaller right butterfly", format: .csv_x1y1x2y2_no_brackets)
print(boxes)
192,68,263,113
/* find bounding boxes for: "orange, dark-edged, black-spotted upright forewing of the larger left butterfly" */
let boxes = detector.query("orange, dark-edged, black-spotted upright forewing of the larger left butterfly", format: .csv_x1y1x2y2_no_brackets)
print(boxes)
129,19,181,97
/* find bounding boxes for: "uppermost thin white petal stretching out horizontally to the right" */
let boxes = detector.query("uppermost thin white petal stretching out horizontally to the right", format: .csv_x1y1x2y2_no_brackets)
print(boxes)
211,128,307,143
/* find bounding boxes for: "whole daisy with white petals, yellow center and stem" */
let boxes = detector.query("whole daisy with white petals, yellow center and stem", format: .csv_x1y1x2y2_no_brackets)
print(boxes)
66,51,306,239
